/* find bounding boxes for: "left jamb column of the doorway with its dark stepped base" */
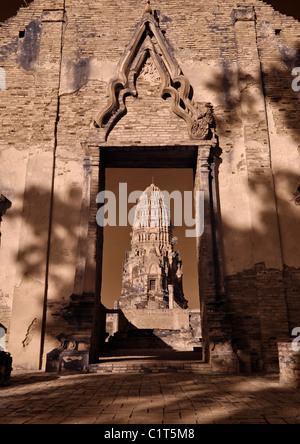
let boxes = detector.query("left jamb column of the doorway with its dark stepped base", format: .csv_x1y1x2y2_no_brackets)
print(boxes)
44,142,106,371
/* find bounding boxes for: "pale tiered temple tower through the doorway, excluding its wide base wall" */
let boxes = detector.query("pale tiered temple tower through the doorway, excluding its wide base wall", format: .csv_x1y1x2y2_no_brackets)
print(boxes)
119,184,187,309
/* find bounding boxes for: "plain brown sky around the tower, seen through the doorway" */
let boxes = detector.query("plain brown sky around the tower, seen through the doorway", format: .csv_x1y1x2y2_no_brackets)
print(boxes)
101,168,200,310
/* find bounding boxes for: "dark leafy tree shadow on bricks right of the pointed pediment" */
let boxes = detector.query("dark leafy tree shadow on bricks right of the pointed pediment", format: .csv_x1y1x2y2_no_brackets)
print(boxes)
205,41,300,146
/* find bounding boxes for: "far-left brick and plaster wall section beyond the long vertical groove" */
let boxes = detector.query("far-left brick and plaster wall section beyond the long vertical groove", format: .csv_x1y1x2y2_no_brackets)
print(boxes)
0,2,63,368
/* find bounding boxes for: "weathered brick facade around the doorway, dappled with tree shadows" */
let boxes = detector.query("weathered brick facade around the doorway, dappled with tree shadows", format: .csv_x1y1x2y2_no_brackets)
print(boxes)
0,0,300,370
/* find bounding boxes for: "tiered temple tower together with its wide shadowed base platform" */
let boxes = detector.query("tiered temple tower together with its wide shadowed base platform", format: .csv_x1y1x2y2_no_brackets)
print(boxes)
106,183,202,354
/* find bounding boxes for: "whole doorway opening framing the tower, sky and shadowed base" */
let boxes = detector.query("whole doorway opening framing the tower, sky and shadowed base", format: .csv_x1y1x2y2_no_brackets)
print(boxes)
101,168,201,359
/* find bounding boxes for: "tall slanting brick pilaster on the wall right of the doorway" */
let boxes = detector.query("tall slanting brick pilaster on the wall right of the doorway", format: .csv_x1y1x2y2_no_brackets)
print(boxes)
233,6,290,370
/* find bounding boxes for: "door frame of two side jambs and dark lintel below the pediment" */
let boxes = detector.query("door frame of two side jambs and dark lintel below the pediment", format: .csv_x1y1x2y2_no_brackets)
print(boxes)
86,142,232,370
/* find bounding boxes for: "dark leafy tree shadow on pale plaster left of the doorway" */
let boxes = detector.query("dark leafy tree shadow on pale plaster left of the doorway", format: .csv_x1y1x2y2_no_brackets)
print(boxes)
5,186,82,294
